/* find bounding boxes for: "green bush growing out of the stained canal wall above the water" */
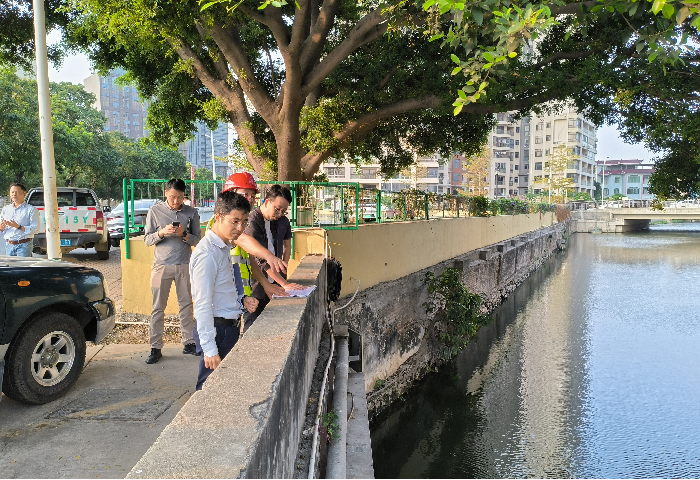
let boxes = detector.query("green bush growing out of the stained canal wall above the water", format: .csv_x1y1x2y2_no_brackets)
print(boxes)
423,268,491,360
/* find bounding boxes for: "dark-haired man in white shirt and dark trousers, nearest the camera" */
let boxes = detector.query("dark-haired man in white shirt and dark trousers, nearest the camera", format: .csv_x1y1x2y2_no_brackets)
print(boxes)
190,190,258,390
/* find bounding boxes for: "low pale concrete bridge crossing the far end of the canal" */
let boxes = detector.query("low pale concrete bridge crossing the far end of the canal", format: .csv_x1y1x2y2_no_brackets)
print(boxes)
571,208,700,233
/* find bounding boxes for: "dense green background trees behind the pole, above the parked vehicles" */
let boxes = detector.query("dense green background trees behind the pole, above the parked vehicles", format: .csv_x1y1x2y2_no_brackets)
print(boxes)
0,69,187,198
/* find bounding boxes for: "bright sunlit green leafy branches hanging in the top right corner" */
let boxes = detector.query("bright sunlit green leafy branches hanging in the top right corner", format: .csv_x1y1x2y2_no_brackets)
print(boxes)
423,0,700,115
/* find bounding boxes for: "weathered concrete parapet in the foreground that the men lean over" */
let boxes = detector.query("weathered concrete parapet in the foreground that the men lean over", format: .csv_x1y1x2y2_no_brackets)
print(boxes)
127,256,327,478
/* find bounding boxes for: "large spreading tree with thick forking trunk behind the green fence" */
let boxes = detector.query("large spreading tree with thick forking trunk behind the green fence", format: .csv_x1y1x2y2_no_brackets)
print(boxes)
0,0,700,192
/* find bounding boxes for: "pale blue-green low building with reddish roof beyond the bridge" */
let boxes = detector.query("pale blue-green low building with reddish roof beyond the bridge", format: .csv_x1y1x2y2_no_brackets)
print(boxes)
596,159,656,200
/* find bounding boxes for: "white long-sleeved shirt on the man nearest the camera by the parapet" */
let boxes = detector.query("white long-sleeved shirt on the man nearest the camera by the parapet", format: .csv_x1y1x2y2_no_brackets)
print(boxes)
190,230,243,357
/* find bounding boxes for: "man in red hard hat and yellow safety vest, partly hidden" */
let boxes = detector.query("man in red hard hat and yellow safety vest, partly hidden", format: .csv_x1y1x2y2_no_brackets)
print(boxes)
207,172,297,298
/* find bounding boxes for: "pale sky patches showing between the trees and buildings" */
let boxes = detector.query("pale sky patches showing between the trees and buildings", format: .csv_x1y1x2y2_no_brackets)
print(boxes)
48,34,654,160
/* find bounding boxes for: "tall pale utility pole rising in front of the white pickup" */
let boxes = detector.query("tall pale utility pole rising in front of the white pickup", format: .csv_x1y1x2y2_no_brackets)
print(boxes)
33,0,61,260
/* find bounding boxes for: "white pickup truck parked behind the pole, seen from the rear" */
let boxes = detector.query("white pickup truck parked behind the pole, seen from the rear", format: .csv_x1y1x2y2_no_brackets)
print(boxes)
26,187,110,260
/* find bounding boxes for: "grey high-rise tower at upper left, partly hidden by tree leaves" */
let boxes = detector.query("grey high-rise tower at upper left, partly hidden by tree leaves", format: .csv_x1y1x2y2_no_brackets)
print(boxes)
83,69,148,139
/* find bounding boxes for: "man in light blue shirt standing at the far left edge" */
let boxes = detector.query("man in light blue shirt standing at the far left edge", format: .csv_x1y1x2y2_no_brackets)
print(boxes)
0,183,39,257
